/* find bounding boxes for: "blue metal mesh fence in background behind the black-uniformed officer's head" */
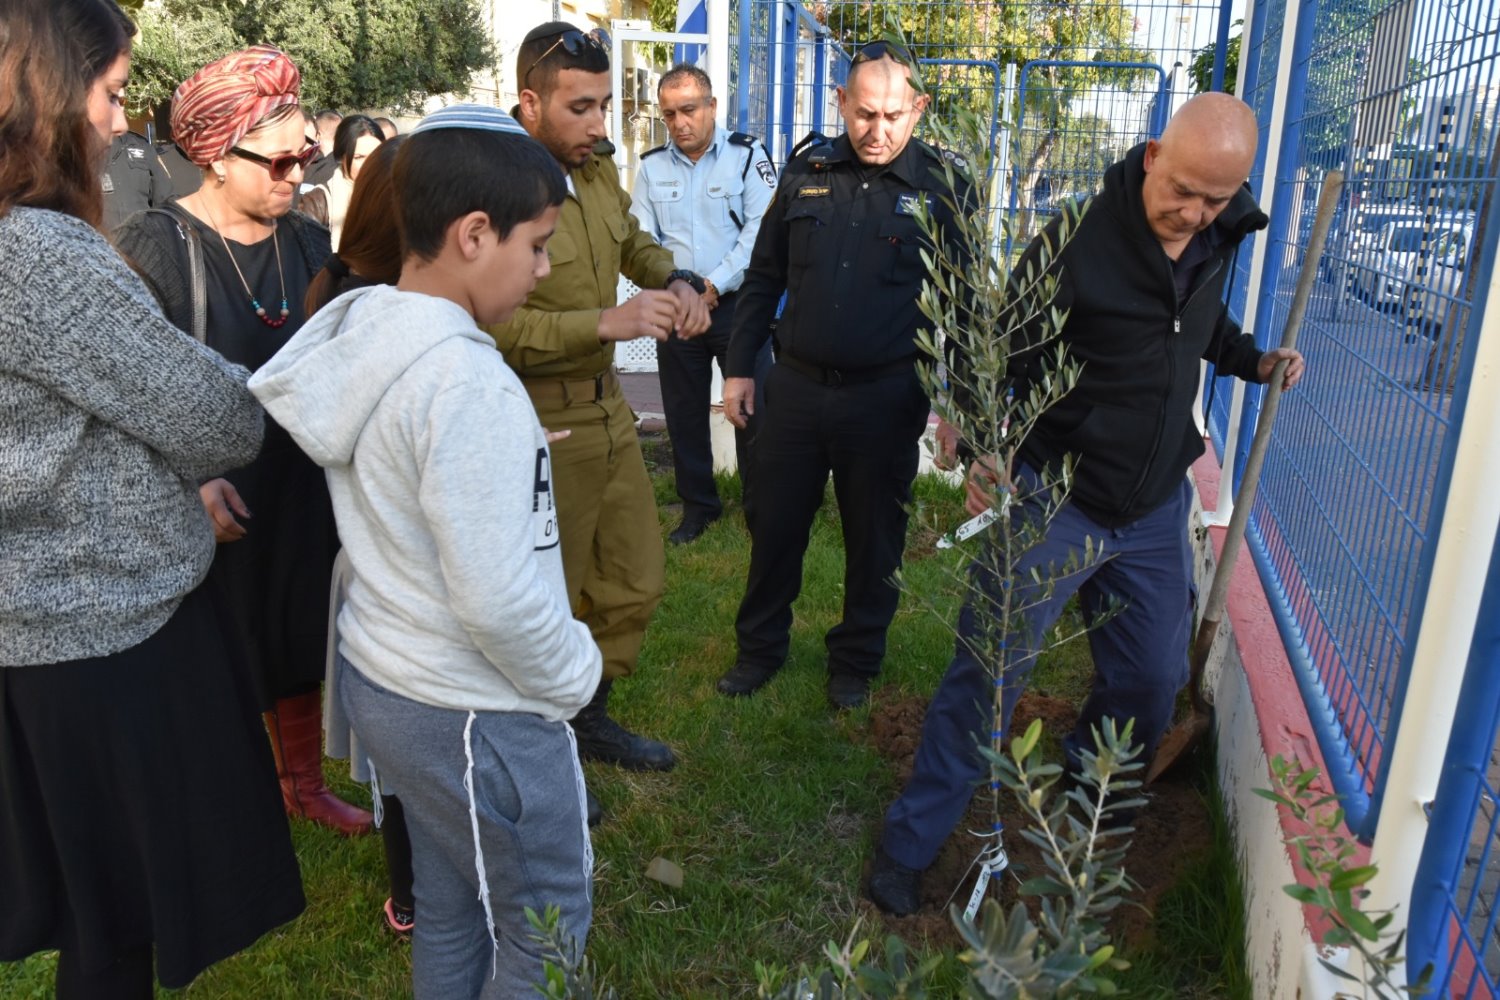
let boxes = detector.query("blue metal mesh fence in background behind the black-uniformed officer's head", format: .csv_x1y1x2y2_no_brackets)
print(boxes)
729,0,1221,239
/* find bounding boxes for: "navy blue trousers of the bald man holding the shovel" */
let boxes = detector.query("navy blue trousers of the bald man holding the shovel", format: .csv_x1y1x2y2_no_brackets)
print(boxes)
881,469,1194,868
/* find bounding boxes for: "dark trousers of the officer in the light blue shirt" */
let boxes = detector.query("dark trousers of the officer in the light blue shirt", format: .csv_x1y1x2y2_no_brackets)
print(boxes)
657,292,771,525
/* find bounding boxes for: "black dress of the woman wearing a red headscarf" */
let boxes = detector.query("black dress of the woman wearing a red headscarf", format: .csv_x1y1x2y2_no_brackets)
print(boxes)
117,213,339,711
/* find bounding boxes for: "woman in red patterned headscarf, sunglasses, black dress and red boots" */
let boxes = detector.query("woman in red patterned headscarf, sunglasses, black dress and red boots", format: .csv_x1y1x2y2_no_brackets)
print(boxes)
116,45,371,835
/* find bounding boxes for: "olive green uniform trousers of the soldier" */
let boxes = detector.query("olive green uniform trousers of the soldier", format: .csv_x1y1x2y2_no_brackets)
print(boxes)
531,373,666,679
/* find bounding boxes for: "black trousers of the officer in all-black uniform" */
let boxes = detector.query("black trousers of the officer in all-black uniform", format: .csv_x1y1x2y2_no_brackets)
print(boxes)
735,363,930,678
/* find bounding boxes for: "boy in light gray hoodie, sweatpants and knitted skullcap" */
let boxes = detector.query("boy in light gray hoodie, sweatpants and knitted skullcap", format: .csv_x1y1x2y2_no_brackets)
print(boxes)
251,105,600,1000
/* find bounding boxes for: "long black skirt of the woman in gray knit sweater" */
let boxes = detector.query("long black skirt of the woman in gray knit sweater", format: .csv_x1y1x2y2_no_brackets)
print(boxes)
0,586,303,988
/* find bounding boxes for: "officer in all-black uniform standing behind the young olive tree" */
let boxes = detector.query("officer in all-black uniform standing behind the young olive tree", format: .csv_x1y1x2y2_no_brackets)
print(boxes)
719,42,969,709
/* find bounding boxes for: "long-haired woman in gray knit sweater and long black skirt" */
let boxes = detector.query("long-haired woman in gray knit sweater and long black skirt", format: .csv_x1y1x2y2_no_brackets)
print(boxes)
0,0,303,1000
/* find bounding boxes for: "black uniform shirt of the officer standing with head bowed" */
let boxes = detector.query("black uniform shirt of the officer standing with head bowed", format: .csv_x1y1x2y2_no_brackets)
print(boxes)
725,136,968,378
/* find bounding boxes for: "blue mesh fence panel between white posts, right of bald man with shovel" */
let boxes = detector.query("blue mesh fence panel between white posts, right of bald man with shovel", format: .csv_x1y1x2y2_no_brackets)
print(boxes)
1212,0,1500,835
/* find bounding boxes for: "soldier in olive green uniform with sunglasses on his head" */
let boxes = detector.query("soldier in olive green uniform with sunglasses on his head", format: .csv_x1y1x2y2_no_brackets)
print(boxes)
489,21,710,771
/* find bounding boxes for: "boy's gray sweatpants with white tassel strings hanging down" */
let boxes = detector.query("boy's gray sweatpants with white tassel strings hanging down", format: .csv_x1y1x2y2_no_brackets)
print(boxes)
338,657,594,1000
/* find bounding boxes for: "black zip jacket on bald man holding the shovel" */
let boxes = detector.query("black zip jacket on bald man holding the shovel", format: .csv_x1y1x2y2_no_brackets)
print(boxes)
1013,144,1268,528
